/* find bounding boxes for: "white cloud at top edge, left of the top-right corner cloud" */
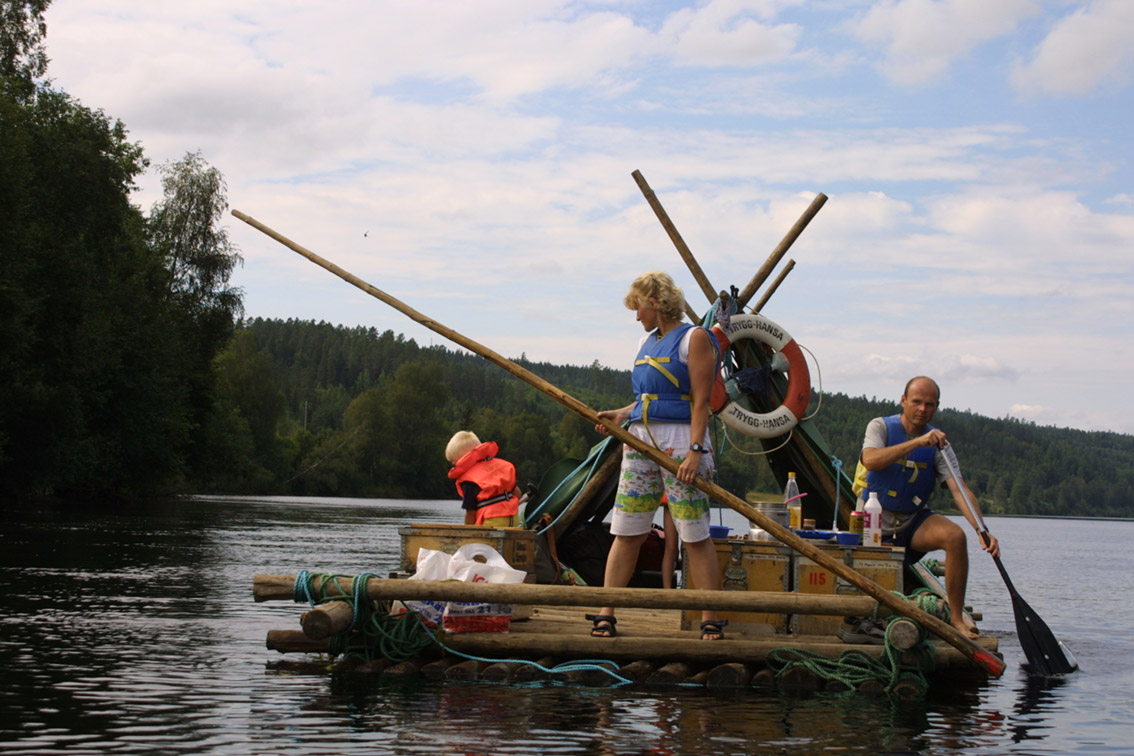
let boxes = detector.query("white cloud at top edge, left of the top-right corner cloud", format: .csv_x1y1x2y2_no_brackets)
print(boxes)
848,0,1038,86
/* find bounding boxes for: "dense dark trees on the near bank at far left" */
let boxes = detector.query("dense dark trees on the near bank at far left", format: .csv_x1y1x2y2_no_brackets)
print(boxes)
0,79,244,495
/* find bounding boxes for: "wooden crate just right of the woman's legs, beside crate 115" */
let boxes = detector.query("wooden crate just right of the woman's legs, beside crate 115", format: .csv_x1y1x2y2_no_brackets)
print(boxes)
682,538,792,635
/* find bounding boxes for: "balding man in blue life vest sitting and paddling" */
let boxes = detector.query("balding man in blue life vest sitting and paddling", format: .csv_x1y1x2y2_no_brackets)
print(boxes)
855,375,1000,638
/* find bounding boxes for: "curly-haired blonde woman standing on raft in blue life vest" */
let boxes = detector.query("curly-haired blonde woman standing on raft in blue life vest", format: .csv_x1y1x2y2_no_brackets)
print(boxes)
586,273,726,640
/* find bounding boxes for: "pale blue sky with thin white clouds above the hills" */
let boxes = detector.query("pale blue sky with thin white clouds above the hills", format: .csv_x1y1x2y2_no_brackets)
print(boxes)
39,0,1134,434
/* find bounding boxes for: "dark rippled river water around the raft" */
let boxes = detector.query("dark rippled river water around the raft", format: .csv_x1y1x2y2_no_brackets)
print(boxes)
0,499,1134,756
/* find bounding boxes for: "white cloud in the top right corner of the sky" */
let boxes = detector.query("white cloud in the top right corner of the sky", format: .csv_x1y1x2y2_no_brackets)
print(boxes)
1012,0,1134,95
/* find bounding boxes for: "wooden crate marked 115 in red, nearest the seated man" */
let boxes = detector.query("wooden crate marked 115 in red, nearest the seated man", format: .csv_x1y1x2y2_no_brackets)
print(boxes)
790,544,905,635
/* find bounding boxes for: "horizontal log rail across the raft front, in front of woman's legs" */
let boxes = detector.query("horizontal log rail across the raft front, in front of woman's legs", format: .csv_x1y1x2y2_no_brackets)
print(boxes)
252,575,885,616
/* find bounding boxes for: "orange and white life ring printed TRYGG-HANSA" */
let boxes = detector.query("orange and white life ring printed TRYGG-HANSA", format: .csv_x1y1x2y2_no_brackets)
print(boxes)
709,314,811,439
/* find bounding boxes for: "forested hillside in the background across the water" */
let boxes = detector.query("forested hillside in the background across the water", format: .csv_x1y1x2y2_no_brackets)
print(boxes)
206,318,1134,516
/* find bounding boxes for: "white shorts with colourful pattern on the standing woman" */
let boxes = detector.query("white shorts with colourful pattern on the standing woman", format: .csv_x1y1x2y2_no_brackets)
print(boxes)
610,447,711,543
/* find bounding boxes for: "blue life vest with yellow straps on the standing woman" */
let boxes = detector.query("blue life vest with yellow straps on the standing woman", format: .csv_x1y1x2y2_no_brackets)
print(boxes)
631,323,696,425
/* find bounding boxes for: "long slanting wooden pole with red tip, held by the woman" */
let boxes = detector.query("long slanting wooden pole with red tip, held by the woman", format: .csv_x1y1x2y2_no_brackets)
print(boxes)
232,210,1005,677
